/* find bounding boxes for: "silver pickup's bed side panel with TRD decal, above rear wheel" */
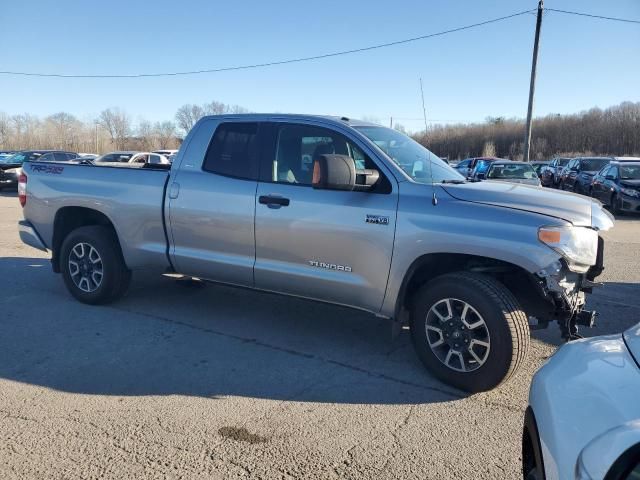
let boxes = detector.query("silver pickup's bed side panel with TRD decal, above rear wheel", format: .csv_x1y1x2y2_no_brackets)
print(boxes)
24,163,168,269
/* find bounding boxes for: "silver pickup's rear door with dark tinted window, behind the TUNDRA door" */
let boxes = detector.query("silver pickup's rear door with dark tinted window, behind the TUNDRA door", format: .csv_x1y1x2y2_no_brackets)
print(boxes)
168,119,259,286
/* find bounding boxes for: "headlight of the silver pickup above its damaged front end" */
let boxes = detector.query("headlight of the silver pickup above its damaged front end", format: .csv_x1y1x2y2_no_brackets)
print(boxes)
538,226,598,273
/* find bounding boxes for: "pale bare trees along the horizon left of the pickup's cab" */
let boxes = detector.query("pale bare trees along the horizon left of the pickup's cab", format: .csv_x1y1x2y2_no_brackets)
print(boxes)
0,100,248,153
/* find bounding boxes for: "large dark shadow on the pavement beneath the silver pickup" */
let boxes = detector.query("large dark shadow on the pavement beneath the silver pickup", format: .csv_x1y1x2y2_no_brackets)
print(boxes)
0,257,463,404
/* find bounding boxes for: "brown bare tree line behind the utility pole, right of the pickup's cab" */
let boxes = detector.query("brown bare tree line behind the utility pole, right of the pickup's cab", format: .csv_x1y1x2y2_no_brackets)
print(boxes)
414,102,640,160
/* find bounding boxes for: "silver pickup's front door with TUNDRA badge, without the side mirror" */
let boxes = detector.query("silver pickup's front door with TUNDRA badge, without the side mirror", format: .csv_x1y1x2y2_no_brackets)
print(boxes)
254,123,398,311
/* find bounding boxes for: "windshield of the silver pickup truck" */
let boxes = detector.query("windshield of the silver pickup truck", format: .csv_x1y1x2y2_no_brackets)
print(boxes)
355,126,464,183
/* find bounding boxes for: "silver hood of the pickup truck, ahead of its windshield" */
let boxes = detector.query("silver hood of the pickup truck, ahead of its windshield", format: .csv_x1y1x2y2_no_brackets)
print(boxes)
442,182,613,230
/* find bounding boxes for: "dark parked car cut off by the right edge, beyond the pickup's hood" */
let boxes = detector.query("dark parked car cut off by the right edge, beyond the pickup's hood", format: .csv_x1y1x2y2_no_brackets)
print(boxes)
589,159,640,214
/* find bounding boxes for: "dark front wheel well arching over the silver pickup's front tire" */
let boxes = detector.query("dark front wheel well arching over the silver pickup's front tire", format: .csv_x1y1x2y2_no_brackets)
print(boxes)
396,253,546,318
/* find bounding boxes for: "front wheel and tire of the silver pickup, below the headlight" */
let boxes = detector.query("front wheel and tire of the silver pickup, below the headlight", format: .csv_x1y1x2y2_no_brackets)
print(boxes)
410,272,530,393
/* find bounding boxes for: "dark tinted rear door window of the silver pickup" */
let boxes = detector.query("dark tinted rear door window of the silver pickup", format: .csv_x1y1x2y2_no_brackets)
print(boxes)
202,123,258,180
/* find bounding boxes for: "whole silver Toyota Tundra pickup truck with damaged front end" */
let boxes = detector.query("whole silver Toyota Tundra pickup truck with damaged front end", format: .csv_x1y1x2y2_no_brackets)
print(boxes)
19,115,613,392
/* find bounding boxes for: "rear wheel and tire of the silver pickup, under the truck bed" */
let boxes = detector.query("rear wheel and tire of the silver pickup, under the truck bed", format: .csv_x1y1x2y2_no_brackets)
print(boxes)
60,226,131,305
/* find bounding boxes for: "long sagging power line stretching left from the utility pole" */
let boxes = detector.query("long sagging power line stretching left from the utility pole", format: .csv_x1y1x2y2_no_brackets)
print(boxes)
0,9,535,78
